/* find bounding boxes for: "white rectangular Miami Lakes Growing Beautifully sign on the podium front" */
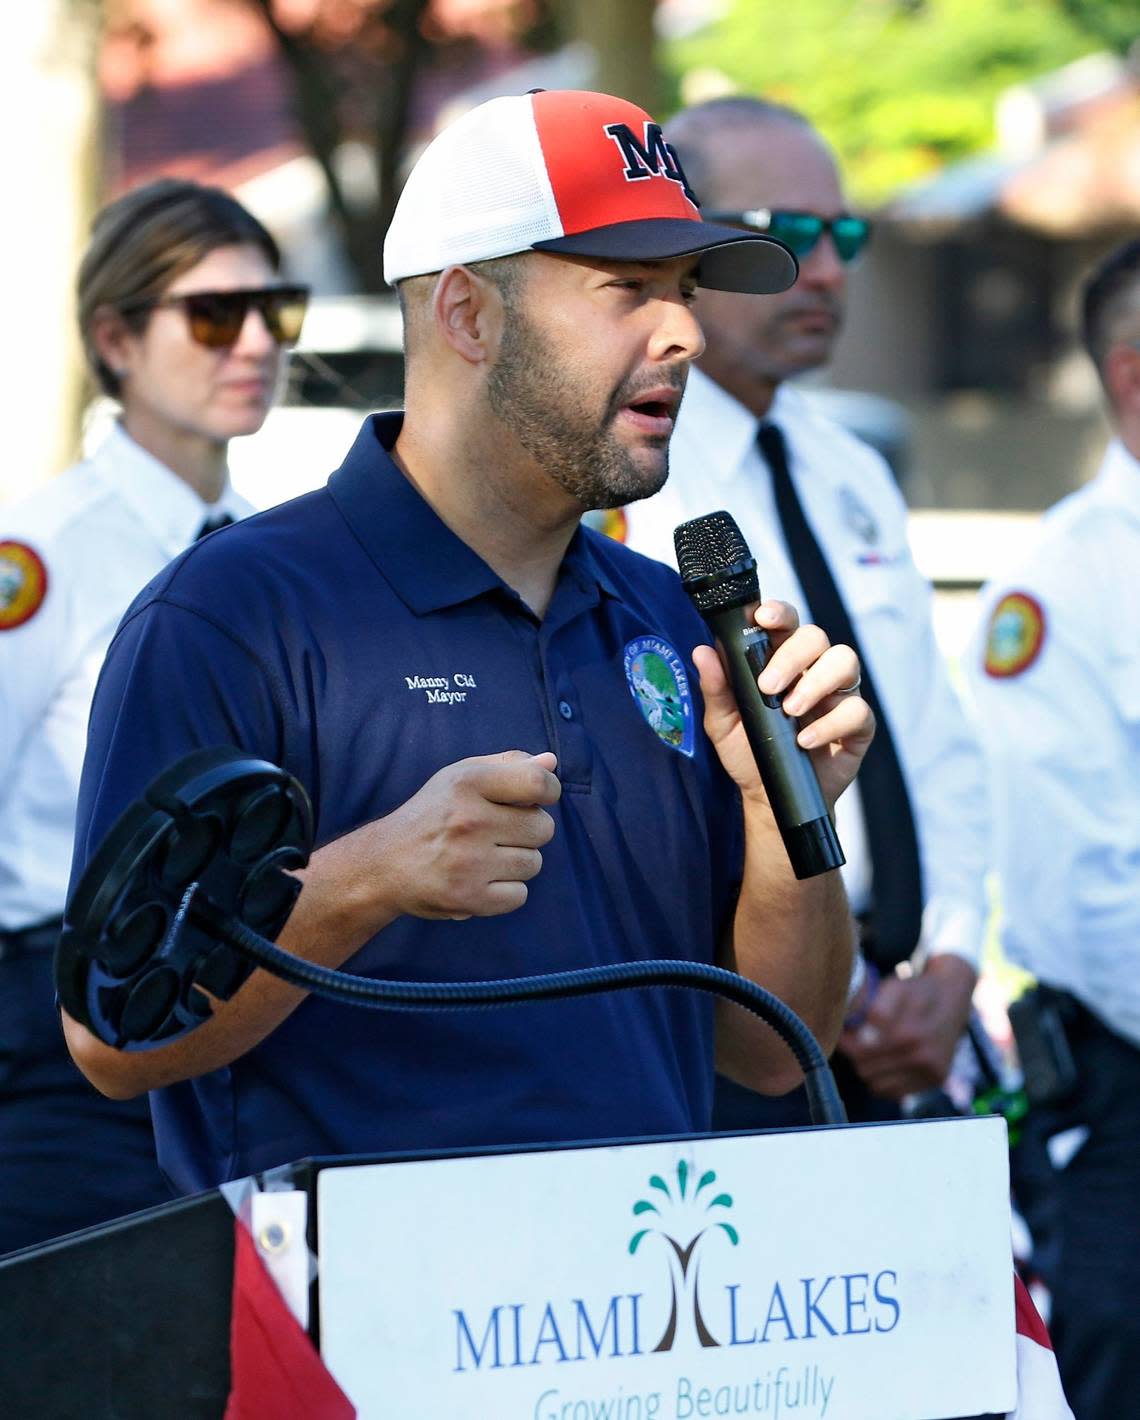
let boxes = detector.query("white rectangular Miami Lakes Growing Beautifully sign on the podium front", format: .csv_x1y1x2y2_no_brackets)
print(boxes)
318,1119,1016,1420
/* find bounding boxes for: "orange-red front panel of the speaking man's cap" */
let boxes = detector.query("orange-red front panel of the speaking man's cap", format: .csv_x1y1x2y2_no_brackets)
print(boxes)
531,91,700,236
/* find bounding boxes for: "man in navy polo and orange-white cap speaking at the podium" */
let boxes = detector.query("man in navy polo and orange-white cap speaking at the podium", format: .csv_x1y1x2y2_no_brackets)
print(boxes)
65,92,873,1190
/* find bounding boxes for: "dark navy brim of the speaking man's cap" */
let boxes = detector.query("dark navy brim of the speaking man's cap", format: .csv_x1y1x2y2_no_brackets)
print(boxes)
532,217,799,295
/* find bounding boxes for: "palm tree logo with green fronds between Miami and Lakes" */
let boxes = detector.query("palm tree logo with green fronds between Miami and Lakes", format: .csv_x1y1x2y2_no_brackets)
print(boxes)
629,1159,740,1352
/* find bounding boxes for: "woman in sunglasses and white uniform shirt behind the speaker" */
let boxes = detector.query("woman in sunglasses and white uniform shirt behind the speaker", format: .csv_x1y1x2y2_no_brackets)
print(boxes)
0,179,307,1252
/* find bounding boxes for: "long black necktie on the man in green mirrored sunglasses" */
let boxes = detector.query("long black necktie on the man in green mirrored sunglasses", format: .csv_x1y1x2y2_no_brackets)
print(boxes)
757,425,923,970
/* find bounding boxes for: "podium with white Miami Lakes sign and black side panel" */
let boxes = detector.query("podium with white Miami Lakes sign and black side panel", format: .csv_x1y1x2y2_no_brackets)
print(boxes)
0,1119,1016,1420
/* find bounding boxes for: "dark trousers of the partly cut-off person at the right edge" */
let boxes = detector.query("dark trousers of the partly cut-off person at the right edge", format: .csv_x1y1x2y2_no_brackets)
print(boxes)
1026,1008,1140,1420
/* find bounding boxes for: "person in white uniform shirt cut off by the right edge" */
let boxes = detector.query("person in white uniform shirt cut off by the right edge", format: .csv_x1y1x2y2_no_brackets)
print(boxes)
965,240,1140,1420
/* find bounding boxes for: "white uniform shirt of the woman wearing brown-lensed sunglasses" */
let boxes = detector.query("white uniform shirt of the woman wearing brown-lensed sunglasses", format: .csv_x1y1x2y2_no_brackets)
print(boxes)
0,425,253,932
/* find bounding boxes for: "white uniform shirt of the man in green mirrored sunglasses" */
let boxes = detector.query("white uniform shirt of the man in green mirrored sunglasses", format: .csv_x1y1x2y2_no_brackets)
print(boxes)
625,369,987,966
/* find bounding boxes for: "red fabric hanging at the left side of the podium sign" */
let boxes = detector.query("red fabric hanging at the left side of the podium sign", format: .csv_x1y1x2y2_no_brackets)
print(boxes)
226,1220,356,1420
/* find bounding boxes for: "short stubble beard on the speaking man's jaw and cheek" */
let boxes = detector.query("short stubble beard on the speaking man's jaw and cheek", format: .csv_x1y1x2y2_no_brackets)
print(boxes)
487,308,669,508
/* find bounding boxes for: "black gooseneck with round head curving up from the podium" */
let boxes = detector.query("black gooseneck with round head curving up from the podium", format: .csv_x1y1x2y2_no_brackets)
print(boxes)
55,747,846,1125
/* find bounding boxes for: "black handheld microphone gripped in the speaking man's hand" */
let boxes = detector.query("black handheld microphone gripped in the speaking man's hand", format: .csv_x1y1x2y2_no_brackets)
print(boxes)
673,513,846,878
